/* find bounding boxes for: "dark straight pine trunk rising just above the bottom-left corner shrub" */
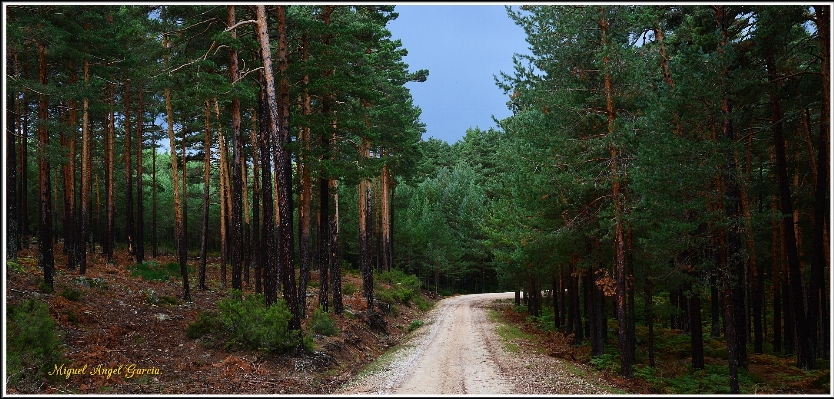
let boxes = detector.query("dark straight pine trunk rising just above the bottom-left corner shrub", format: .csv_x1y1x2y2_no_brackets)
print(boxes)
38,43,55,291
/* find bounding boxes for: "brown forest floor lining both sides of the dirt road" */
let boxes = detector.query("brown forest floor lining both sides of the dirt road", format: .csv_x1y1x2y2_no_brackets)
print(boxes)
5,246,831,395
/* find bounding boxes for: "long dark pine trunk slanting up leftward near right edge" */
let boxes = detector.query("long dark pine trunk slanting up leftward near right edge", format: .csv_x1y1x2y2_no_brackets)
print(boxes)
766,53,814,370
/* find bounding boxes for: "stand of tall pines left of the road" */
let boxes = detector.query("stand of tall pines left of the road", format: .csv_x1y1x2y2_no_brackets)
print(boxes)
5,5,428,336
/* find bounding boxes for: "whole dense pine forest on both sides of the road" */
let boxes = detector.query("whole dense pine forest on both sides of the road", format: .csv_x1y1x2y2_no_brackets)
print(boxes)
4,5,831,393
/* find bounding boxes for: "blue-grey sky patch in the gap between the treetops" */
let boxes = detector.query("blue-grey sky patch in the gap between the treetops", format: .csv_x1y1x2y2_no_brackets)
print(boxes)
388,3,529,144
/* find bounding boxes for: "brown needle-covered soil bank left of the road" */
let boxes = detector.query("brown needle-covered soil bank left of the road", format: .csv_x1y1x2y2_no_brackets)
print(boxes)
6,247,436,394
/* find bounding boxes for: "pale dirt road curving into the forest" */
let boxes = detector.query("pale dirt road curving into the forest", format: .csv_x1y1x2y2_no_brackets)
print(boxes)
337,292,607,395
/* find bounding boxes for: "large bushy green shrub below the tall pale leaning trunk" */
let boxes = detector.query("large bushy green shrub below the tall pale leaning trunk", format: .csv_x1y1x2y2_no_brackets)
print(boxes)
217,290,303,353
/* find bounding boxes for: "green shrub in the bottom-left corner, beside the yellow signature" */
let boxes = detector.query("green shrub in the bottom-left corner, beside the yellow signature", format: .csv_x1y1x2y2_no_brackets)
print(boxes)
6,299,65,393
